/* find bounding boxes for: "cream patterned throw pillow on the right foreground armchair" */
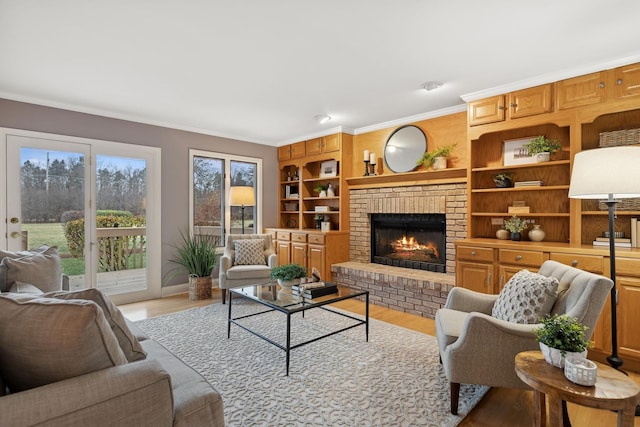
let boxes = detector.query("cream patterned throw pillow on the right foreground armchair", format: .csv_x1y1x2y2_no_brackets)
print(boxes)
491,270,558,323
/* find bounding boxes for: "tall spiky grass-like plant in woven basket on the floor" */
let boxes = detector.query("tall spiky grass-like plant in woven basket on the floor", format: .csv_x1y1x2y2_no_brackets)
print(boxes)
169,232,218,300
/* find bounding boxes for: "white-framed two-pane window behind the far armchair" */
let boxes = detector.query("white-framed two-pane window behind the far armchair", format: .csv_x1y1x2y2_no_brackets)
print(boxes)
189,150,262,246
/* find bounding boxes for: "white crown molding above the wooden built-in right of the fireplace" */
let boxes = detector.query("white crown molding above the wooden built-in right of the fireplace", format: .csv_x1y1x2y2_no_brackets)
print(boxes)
460,52,640,102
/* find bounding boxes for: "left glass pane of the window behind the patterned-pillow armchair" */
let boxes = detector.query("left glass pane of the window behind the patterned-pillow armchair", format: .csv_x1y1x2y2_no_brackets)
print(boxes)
192,156,224,246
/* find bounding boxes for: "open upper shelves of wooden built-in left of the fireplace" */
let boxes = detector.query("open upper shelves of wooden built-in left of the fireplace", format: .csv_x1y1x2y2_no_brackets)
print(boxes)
279,134,352,231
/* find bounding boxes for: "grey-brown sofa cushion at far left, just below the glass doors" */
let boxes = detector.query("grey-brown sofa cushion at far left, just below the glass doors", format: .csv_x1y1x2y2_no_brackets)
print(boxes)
0,246,62,292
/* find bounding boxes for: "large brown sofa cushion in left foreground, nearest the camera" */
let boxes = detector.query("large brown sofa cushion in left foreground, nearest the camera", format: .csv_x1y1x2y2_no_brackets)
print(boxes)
0,293,127,392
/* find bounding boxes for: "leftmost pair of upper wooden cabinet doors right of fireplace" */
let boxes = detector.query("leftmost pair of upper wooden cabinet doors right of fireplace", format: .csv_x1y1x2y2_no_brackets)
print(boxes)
467,84,553,126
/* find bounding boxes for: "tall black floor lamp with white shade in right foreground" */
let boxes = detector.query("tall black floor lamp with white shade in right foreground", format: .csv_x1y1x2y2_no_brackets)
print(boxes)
569,146,640,380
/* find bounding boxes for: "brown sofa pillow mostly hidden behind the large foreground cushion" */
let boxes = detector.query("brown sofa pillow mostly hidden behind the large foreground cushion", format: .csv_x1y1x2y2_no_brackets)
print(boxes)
42,289,147,362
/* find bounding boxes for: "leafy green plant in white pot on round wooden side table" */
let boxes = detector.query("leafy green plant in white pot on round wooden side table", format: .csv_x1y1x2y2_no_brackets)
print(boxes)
533,314,591,368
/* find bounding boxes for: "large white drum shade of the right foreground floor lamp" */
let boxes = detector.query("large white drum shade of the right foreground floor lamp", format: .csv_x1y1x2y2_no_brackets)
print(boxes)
569,146,640,199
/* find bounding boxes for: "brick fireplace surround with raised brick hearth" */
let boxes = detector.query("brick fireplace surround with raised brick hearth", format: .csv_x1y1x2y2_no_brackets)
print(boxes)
331,182,467,318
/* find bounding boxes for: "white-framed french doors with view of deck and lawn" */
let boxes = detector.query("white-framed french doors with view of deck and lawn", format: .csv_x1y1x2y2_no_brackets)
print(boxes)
2,130,161,303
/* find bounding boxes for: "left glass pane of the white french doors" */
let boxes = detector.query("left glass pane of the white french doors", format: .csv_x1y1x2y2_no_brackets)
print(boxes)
20,147,85,280
